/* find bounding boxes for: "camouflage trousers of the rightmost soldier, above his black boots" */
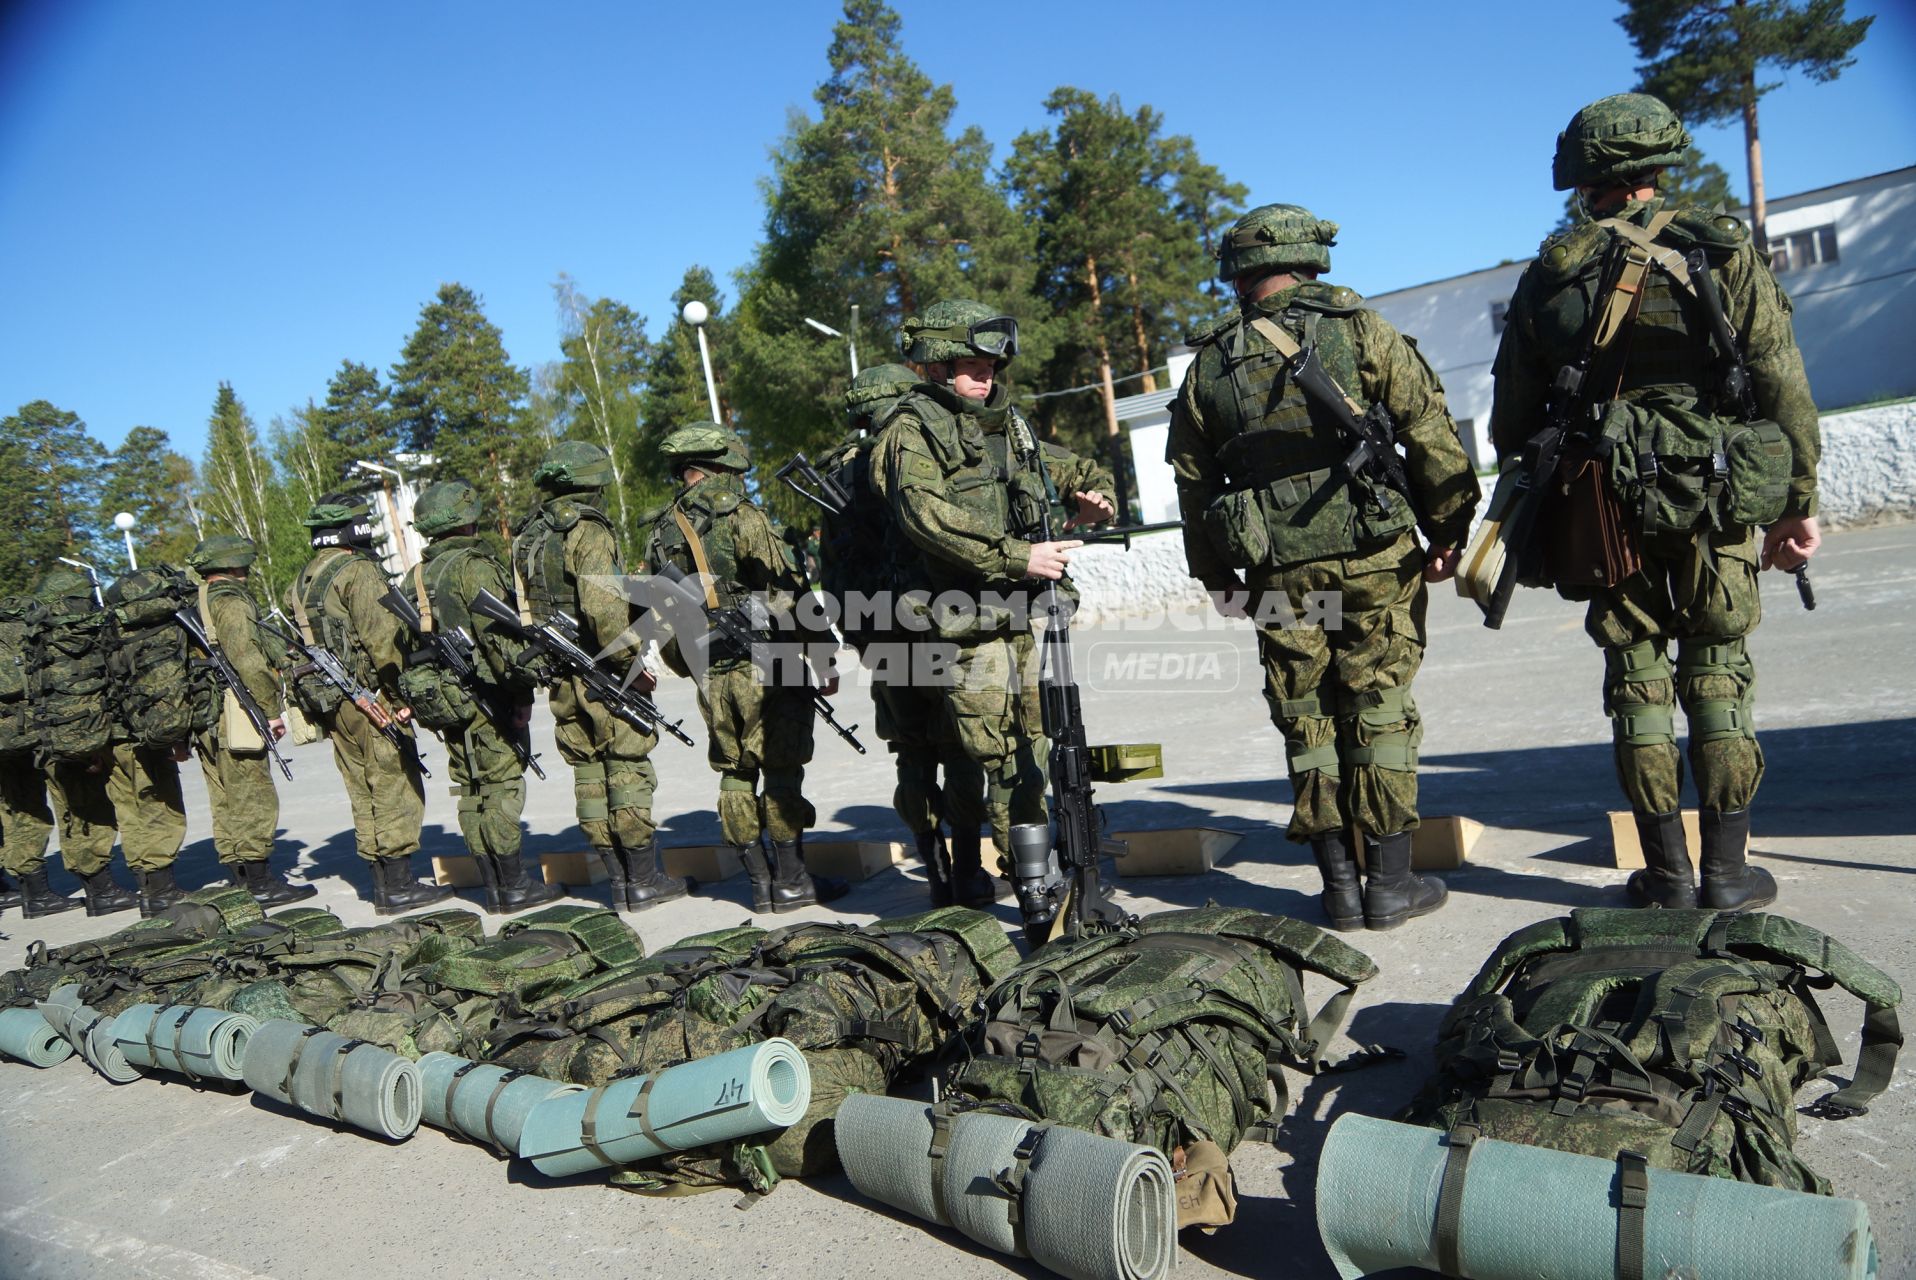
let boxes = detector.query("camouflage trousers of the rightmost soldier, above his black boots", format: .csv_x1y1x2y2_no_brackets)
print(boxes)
1565,529,1763,814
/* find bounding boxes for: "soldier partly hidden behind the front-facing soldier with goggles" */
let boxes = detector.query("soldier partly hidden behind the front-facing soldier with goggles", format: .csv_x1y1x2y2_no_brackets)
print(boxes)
818,364,994,906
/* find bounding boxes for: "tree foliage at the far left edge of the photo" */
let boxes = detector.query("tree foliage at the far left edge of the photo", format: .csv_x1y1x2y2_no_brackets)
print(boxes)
0,400,111,594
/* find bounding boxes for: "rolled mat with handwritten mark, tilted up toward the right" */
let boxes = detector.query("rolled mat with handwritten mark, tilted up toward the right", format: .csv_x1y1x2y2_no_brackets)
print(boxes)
519,1037,812,1177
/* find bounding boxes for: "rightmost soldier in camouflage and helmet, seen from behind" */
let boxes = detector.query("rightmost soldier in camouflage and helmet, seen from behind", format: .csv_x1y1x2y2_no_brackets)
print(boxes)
1491,94,1820,910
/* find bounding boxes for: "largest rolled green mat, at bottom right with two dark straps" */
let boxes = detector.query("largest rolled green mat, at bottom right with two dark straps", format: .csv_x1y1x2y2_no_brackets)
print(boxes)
1316,1115,1878,1280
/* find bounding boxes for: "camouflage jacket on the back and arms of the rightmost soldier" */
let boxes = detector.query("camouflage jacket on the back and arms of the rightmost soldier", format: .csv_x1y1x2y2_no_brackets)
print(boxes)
1491,199,1822,515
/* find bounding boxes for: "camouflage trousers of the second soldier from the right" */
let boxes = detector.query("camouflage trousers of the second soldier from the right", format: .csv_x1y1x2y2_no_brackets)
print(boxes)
1251,535,1426,841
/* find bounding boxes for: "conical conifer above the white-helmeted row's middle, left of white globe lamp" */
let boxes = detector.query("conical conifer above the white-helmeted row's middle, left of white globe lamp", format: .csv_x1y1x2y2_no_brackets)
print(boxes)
391,284,538,519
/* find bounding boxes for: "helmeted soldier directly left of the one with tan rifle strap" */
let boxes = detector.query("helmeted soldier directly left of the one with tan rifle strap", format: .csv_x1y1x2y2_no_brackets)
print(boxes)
512,441,688,910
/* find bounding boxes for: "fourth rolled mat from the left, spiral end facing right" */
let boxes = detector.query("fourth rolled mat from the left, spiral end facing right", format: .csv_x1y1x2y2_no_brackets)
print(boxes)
240,1017,422,1138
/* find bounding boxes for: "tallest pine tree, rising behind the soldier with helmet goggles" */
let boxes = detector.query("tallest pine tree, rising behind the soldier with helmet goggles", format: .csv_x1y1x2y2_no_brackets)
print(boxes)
715,0,1048,502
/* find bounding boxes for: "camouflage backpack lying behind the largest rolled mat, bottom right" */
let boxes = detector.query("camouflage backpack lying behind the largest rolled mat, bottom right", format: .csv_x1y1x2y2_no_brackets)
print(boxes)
1401,908,1903,1196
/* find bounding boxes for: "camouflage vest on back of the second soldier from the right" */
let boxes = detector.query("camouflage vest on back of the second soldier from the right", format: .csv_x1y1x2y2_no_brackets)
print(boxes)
1188,293,1416,569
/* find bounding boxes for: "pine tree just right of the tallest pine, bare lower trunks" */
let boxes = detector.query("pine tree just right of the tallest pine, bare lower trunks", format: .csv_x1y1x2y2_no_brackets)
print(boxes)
1004,88,1243,435
